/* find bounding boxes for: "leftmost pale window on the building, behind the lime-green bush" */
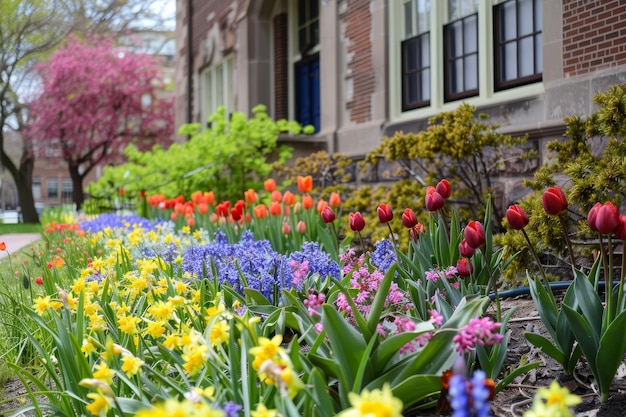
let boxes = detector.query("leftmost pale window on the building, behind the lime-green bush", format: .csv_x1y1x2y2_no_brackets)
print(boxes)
200,56,234,127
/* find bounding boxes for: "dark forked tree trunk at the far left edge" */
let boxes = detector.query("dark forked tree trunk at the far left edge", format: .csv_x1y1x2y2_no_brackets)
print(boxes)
0,136,39,223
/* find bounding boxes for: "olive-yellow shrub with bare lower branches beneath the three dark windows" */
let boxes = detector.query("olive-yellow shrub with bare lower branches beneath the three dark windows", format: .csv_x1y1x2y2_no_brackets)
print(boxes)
365,103,532,229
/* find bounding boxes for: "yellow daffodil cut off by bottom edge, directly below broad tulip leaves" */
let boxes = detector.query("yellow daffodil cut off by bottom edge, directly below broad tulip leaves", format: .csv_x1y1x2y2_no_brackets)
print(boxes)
338,384,402,417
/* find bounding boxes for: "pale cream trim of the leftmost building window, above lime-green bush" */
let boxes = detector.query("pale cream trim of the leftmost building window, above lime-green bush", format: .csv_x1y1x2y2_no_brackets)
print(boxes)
200,55,235,127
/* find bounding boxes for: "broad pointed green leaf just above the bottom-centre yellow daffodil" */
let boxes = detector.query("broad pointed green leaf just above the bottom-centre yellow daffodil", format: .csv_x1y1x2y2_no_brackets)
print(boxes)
322,304,367,387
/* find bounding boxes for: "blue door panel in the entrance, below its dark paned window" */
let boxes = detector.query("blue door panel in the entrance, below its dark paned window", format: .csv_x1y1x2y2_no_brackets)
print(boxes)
295,55,320,132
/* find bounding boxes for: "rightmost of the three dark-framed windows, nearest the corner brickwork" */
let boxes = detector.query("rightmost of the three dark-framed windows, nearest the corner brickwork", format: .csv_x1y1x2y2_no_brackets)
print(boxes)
493,0,543,91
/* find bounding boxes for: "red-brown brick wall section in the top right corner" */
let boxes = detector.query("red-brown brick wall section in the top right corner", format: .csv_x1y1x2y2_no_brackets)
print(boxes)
563,0,626,77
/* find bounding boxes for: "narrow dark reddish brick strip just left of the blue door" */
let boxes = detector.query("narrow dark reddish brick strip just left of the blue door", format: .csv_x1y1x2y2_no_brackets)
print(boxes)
274,13,289,119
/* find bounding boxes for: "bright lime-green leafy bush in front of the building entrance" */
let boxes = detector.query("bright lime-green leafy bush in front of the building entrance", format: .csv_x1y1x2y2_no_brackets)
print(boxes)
89,105,301,205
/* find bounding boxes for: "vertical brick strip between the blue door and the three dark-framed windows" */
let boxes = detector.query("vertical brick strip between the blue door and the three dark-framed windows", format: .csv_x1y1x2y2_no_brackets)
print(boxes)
340,0,375,123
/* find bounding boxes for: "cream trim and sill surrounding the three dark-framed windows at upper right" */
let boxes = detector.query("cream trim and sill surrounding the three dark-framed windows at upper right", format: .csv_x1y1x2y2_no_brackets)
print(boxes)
388,0,544,122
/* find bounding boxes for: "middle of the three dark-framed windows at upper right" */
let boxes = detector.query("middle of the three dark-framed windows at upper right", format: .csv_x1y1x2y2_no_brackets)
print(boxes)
443,10,478,101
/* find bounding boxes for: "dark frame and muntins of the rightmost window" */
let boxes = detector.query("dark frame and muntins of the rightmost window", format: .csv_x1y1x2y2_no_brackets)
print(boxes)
492,0,543,91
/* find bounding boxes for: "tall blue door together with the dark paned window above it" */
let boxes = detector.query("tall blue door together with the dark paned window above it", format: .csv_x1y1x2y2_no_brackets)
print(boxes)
293,0,320,132
